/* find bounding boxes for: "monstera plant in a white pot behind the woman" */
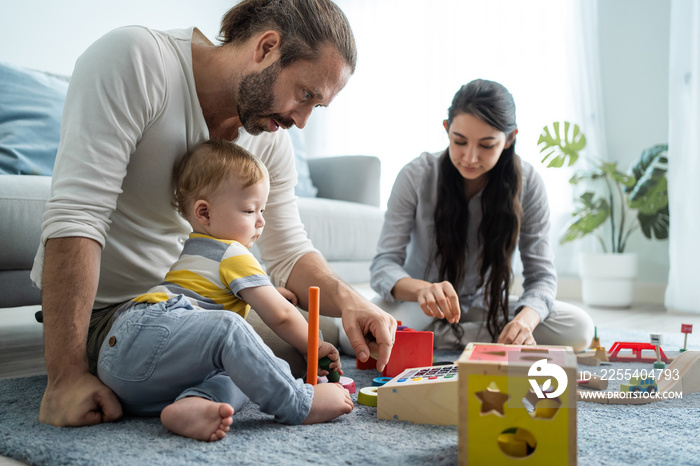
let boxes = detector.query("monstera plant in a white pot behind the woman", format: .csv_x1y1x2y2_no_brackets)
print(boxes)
537,122,669,307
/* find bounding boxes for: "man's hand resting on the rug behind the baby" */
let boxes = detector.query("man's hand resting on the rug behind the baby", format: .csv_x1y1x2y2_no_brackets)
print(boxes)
39,372,122,427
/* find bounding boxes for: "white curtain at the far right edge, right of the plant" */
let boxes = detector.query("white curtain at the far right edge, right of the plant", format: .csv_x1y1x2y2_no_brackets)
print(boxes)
666,0,700,312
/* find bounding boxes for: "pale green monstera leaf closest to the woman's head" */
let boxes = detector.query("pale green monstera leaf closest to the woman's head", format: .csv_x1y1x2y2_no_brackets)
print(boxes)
537,121,586,167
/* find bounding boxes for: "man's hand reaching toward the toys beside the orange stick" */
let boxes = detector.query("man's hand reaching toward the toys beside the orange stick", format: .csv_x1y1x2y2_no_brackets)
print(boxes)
342,301,396,372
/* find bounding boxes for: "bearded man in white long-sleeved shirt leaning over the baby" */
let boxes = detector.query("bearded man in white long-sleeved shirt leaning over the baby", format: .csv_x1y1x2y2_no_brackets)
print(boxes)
32,0,396,426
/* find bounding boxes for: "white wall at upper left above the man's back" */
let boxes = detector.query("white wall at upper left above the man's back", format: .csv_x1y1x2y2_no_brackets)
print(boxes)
0,0,235,75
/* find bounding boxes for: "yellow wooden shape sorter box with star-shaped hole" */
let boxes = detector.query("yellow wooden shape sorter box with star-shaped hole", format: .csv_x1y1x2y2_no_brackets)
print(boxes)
457,343,577,465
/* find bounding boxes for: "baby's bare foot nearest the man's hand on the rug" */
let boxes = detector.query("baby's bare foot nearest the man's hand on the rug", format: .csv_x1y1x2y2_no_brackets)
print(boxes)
160,396,233,442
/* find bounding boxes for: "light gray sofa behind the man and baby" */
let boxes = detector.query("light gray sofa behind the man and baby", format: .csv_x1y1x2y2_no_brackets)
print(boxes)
0,156,383,313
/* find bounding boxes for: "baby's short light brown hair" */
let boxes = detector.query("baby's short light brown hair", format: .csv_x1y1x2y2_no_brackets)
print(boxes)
173,139,269,218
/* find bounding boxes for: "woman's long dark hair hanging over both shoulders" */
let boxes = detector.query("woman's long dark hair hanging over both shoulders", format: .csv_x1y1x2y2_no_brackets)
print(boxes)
434,79,522,341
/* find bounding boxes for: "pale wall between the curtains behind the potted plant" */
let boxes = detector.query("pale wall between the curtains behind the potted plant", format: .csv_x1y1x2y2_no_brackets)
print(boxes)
598,0,671,283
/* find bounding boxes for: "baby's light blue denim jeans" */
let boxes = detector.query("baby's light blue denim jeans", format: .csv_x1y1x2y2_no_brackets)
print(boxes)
97,296,313,424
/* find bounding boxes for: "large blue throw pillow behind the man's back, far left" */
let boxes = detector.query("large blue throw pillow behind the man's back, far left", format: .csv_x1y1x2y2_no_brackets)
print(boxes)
0,63,68,176
